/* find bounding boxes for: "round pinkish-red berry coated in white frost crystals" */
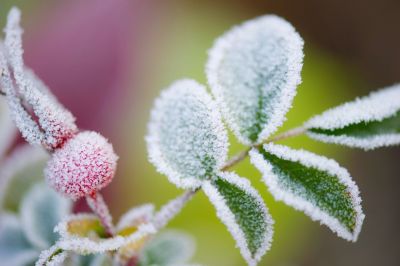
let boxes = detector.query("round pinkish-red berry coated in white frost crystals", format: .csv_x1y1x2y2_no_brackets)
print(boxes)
45,131,118,199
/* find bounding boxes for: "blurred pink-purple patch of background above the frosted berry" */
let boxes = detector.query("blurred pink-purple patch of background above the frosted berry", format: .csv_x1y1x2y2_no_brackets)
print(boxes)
24,0,149,137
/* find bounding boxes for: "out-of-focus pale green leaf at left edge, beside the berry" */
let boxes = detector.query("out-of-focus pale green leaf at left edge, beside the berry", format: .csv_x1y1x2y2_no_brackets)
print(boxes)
0,145,49,212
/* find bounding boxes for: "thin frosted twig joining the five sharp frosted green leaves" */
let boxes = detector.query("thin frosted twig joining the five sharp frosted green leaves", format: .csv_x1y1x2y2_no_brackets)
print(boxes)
153,127,306,230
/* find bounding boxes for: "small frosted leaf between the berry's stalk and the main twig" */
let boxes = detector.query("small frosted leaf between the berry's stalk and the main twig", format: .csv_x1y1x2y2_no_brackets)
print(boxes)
116,204,154,231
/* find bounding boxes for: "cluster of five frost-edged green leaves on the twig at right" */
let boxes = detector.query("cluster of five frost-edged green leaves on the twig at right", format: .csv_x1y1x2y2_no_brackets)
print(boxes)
146,11,400,265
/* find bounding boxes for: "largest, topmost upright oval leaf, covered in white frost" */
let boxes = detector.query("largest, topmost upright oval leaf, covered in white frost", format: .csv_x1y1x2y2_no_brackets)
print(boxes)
206,15,303,145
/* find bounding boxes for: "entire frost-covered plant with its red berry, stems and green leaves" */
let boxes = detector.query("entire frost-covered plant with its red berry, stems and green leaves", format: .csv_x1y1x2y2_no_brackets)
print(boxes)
0,5,400,266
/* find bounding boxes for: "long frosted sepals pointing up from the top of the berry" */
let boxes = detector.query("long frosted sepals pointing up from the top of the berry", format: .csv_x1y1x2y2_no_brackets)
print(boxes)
0,8,78,150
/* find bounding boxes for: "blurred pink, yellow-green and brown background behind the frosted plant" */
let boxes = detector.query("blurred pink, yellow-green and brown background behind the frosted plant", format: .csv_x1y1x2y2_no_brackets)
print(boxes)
0,0,400,266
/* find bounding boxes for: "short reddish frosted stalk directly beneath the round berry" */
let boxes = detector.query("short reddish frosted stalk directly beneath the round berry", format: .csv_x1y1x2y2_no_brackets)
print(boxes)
86,192,114,236
